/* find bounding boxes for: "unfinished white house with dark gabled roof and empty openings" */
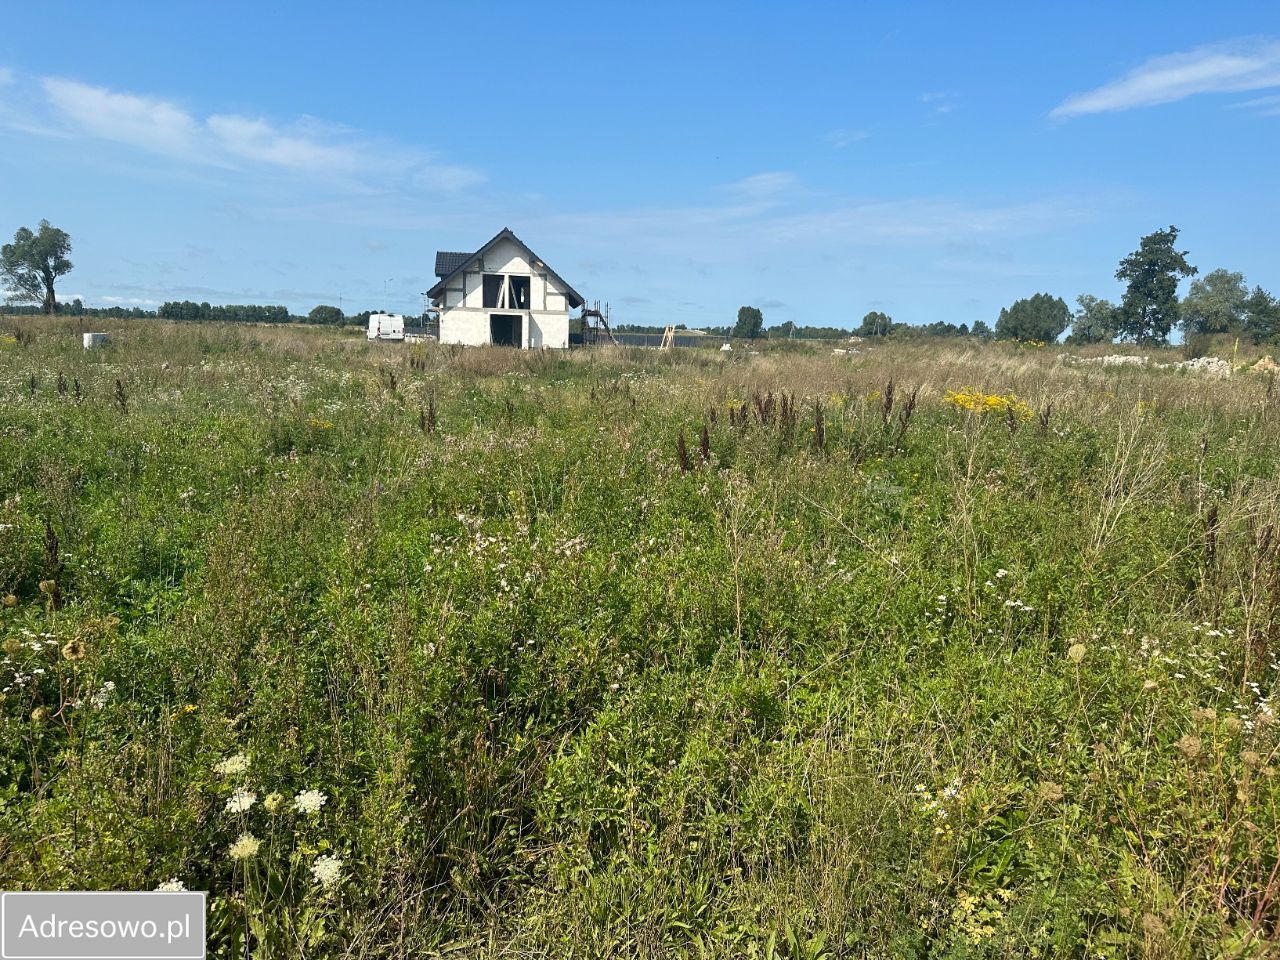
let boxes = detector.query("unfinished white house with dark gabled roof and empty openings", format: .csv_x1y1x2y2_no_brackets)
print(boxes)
426,229,584,349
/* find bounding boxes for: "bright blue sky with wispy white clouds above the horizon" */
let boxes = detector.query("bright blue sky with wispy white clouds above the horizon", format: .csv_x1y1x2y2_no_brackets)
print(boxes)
0,0,1280,326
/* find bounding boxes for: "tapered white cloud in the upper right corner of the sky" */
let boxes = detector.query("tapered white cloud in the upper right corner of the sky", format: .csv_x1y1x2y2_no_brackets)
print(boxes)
1050,38,1280,119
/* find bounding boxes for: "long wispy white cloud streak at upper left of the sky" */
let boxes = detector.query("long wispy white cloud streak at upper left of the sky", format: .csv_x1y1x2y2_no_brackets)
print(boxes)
11,72,484,193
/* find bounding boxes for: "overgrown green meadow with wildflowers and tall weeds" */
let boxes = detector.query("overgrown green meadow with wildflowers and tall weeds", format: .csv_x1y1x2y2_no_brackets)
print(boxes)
0,319,1280,960
